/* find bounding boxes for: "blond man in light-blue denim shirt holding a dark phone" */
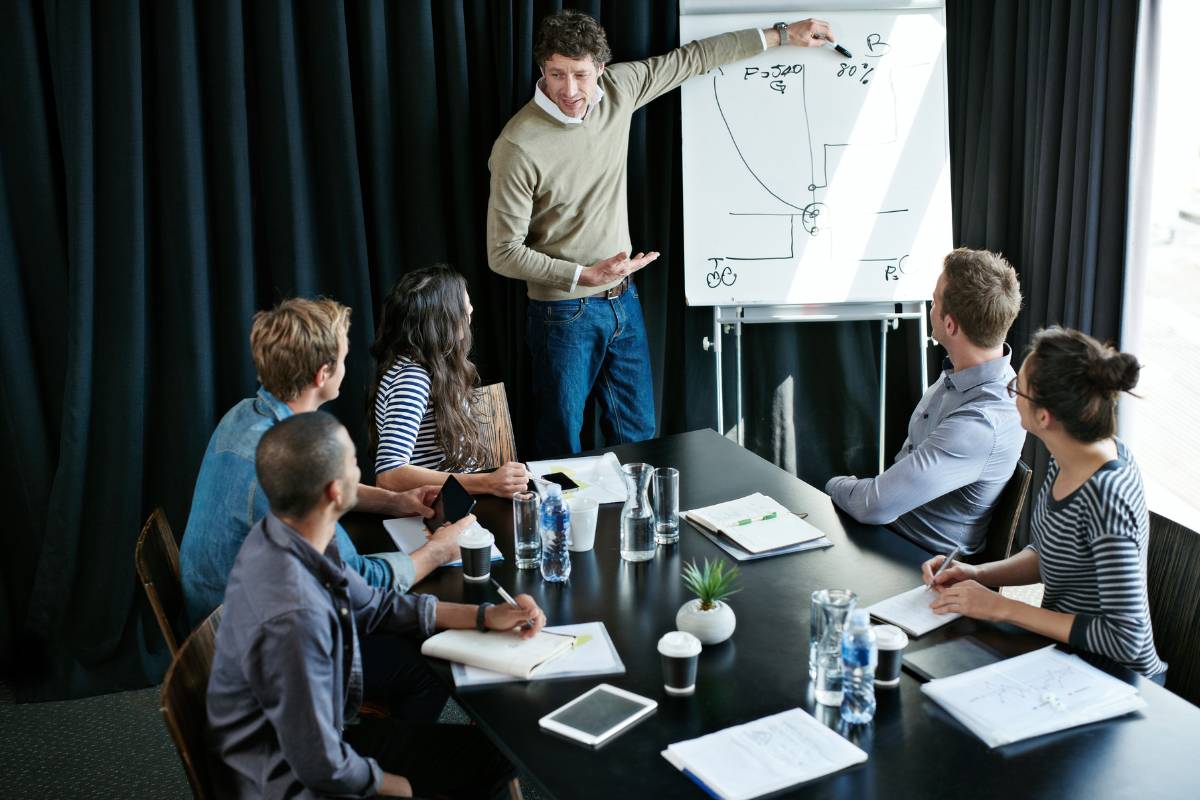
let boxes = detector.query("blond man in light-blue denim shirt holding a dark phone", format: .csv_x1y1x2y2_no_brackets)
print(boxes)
179,293,463,625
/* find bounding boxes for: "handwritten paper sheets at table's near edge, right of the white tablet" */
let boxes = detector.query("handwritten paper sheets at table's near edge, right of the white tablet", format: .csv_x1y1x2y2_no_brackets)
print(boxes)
662,709,866,800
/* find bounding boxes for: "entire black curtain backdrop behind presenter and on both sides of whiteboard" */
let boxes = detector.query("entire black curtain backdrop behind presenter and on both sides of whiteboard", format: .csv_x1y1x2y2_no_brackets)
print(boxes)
0,0,1136,698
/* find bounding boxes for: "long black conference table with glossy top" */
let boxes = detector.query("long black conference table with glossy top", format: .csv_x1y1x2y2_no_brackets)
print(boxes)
352,431,1200,800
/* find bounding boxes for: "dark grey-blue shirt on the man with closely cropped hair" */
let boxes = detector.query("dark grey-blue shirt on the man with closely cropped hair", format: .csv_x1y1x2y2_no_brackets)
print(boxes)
208,513,437,799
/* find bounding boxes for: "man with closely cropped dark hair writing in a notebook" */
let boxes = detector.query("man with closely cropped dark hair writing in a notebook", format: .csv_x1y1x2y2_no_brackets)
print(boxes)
208,411,546,799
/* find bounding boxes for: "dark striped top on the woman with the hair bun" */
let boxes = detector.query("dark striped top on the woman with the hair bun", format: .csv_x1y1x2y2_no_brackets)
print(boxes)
1030,440,1166,675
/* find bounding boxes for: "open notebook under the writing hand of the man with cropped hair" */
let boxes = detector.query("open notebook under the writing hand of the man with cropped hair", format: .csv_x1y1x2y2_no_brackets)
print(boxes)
421,630,575,680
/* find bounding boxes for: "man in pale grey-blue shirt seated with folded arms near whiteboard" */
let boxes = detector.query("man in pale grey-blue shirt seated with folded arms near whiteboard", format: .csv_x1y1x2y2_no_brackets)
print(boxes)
826,248,1025,554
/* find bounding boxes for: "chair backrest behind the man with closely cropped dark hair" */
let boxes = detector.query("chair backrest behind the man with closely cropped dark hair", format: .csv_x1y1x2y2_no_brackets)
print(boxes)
160,606,222,800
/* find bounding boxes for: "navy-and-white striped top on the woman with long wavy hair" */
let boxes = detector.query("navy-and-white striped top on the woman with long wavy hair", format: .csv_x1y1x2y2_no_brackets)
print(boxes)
374,359,445,475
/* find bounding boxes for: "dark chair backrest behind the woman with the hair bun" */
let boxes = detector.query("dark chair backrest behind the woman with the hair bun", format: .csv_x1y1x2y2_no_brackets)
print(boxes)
1146,512,1200,705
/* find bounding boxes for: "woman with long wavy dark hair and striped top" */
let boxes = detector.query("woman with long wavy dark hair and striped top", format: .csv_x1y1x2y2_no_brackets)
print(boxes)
367,264,528,498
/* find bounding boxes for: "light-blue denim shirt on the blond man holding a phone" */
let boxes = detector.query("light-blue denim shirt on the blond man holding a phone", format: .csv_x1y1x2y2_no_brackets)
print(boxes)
179,387,415,625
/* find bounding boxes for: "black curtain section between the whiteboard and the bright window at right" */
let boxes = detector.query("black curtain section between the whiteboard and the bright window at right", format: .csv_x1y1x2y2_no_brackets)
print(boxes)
947,0,1140,545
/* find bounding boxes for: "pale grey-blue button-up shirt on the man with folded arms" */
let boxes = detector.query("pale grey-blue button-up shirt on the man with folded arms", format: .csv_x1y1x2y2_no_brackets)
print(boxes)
826,344,1025,554
